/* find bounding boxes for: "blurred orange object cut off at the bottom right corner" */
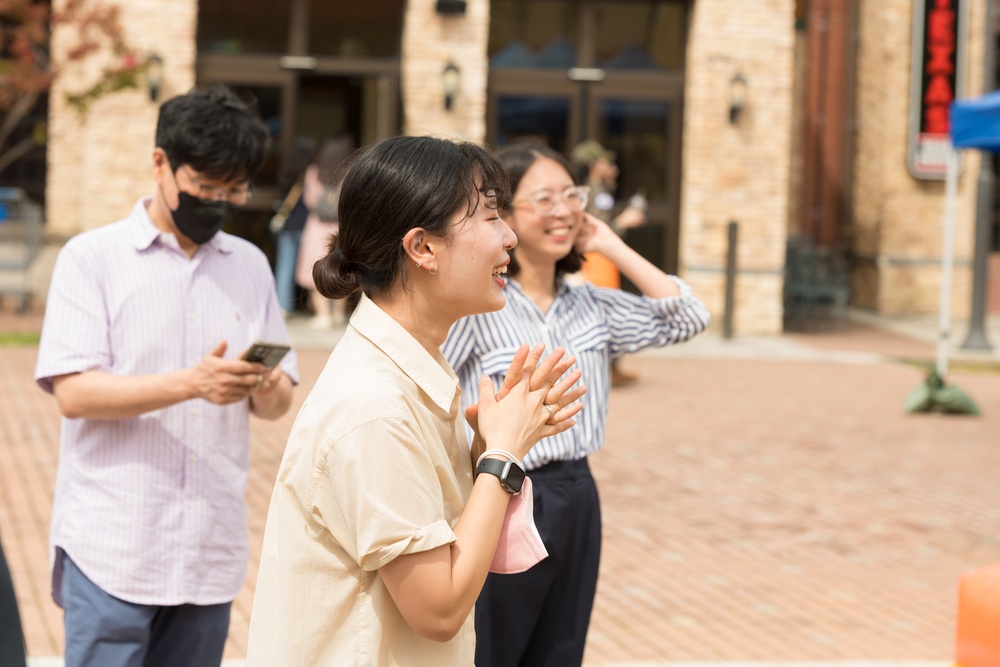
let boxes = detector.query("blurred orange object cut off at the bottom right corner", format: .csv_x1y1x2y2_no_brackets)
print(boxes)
955,563,1000,667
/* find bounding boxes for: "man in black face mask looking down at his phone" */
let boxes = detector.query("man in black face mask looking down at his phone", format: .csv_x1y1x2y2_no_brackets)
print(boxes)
35,87,298,667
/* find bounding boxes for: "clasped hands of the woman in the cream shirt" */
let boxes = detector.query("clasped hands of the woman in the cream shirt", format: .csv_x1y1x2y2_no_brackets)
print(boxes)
466,345,587,458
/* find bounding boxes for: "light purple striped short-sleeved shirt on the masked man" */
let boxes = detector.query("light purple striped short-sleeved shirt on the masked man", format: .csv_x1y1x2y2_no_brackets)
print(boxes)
35,199,298,605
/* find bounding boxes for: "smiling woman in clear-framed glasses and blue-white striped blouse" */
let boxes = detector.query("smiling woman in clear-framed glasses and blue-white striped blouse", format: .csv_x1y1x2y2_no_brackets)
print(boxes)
442,144,709,667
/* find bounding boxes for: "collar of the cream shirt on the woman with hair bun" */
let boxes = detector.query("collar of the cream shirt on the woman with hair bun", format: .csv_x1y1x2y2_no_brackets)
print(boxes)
351,294,458,412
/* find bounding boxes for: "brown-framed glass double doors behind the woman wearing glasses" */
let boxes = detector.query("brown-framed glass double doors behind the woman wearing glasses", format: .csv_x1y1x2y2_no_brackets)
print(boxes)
487,0,688,276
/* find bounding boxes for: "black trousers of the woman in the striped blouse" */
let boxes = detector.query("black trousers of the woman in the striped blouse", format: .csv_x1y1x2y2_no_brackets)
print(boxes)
476,459,601,667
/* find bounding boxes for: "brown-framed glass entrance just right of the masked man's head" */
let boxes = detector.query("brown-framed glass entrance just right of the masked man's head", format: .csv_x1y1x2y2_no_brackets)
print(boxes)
197,0,403,259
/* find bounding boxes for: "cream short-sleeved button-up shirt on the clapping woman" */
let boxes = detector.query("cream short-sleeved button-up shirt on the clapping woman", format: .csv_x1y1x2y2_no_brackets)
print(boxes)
247,297,475,667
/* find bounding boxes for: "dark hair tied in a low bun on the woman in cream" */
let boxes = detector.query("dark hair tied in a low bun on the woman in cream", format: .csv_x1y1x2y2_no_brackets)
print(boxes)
313,137,511,299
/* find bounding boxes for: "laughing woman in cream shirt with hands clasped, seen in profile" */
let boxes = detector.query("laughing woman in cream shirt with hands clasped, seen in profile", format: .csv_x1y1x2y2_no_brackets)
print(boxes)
247,137,584,667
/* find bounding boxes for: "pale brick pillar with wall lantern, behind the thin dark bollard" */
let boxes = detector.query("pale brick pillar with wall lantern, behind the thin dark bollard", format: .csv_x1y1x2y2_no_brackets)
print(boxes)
680,0,795,334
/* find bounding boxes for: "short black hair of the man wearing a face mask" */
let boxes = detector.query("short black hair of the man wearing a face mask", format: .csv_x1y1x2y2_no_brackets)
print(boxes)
156,86,270,181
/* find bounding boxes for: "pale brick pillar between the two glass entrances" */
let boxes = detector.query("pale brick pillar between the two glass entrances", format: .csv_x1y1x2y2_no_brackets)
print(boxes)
402,0,490,143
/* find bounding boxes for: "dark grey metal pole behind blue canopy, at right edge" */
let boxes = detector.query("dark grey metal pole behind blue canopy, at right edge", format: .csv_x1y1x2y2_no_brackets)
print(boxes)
962,0,997,350
